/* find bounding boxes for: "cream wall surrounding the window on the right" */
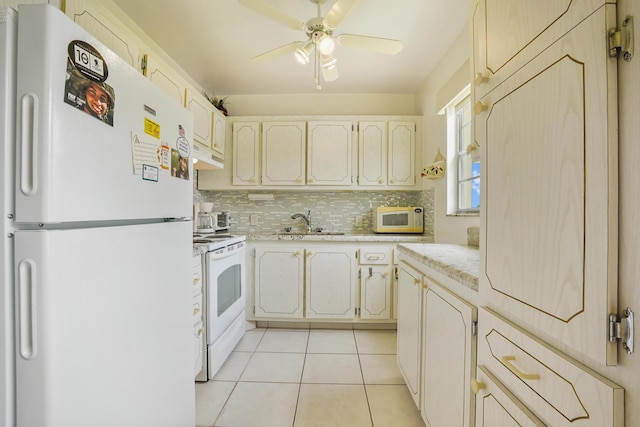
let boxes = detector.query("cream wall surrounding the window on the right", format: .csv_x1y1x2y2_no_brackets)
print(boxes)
416,26,480,244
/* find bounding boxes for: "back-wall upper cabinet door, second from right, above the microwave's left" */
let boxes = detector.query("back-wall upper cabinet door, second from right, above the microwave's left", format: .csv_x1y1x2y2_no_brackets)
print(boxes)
358,121,387,187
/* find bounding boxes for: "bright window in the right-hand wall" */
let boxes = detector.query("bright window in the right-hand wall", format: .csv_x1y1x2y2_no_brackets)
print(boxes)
445,87,480,215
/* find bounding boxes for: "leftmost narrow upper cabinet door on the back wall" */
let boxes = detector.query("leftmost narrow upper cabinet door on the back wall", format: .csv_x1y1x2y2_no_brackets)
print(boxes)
232,122,260,185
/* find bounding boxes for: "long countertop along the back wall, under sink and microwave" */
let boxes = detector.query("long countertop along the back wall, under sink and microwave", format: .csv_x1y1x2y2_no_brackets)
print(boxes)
247,233,433,243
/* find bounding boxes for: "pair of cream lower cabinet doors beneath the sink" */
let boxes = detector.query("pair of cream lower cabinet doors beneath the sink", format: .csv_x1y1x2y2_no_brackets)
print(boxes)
254,245,357,319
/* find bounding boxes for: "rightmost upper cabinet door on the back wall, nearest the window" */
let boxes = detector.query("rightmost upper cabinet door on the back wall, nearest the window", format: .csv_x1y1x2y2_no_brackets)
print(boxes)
387,121,416,187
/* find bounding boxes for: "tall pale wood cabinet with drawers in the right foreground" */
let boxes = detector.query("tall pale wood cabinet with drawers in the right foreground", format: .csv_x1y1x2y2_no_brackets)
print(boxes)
470,0,624,426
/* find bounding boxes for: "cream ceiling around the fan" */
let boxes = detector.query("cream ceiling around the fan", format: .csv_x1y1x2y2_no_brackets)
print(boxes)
114,0,470,96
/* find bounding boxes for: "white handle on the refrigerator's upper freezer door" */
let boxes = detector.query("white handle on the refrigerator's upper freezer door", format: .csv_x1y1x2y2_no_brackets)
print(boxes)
19,93,38,196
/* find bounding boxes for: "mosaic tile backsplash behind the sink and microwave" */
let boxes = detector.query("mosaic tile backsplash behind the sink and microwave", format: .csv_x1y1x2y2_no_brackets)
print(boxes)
193,174,434,236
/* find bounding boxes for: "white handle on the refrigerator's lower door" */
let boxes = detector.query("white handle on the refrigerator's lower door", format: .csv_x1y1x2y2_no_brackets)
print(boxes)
17,259,38,360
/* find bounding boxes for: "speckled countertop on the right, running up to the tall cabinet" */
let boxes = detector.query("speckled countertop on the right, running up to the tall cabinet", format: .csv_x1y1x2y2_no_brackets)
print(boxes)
397,243,480,291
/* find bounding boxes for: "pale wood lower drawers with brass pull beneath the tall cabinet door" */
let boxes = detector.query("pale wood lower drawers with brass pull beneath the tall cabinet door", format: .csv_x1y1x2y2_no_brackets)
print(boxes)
474,308,624,427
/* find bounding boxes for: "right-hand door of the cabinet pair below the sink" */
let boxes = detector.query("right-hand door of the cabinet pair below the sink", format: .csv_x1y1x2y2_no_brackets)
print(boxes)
305,247,356,319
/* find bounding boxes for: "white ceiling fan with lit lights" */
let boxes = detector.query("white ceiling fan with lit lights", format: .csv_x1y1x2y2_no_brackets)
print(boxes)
238,0,402,89
